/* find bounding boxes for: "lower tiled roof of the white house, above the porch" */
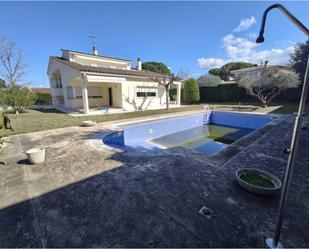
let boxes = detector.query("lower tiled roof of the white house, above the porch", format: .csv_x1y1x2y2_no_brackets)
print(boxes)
51,56,169,78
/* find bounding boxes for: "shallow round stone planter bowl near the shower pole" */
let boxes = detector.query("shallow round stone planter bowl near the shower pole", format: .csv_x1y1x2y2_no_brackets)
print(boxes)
236,168,282,196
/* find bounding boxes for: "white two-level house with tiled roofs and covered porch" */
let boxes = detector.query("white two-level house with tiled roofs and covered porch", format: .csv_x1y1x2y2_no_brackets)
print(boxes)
47,48,181,114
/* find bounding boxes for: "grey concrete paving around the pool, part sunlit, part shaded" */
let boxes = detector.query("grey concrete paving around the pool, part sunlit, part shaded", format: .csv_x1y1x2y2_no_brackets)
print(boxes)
0,113,309,247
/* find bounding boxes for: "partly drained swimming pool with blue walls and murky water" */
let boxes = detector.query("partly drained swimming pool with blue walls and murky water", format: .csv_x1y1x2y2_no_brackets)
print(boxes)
103,111,272,155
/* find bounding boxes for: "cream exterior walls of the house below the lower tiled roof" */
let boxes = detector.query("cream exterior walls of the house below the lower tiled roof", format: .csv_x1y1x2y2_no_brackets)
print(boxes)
48,56,166,111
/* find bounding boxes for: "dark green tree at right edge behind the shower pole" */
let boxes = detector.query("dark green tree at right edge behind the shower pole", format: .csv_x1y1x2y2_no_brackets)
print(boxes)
290,40,309,82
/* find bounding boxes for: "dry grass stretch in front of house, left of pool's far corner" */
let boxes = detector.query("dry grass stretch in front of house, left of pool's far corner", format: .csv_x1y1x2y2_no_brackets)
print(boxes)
0,105,202,137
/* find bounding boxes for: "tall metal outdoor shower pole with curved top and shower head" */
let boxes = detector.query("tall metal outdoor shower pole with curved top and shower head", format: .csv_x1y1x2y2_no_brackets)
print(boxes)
256,4,309,248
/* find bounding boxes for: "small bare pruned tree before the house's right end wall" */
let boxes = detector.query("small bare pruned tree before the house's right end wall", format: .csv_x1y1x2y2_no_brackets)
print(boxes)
150,69,188,110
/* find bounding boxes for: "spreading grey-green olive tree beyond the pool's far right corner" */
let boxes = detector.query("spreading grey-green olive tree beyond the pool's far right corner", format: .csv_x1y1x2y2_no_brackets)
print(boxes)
238,70,300,107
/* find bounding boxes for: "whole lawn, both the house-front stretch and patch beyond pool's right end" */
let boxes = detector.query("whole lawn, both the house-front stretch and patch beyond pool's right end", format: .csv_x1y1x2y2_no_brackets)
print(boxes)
0,103,309,137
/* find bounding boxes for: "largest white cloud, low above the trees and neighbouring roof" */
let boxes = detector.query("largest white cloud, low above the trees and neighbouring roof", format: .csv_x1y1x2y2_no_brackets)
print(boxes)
197,34,294,69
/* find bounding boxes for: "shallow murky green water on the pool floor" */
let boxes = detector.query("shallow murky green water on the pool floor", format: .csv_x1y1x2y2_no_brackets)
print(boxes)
150,125,253,154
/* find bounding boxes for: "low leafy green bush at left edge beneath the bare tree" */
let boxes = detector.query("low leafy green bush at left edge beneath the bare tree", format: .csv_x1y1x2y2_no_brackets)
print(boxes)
0,85,35,112
